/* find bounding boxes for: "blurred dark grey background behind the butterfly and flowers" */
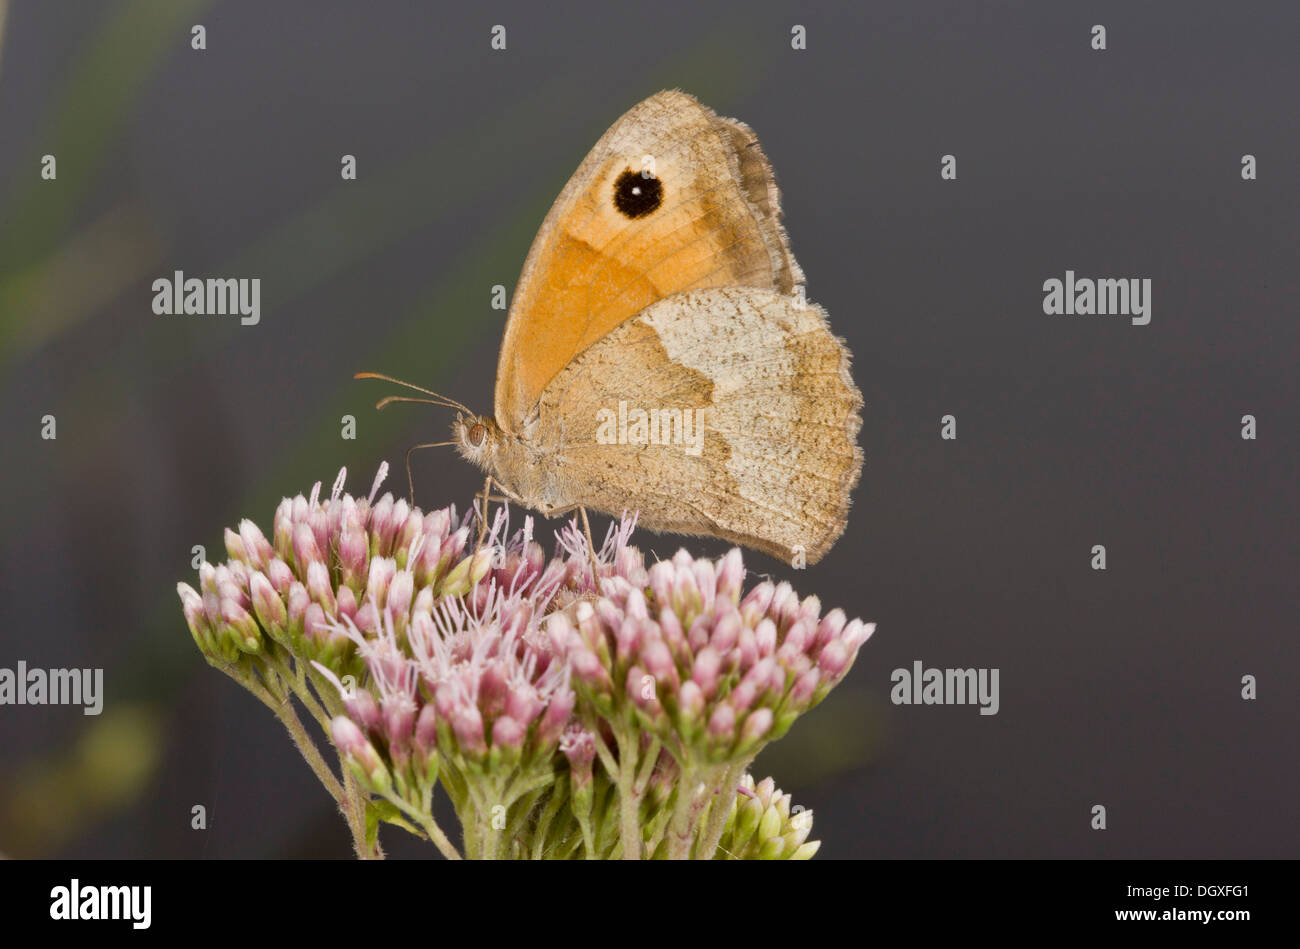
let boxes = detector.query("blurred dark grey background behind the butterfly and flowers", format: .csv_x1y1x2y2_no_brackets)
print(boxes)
0,0,1300,858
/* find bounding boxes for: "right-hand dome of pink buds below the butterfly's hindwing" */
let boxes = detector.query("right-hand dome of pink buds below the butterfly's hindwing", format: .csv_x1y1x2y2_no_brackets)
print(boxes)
549,549,872,762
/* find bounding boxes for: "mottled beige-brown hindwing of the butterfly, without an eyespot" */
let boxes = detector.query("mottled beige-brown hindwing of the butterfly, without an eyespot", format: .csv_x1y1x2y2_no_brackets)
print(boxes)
536,287,862,563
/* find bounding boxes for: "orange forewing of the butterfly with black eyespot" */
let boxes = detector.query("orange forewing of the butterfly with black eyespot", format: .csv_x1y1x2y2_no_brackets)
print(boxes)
495,92,802,433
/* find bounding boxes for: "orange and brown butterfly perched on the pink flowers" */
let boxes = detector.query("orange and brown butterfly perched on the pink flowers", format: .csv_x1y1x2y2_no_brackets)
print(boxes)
358,91,863,566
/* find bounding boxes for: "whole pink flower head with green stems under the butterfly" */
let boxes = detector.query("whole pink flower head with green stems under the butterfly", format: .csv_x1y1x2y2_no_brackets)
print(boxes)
178,465,872,858
